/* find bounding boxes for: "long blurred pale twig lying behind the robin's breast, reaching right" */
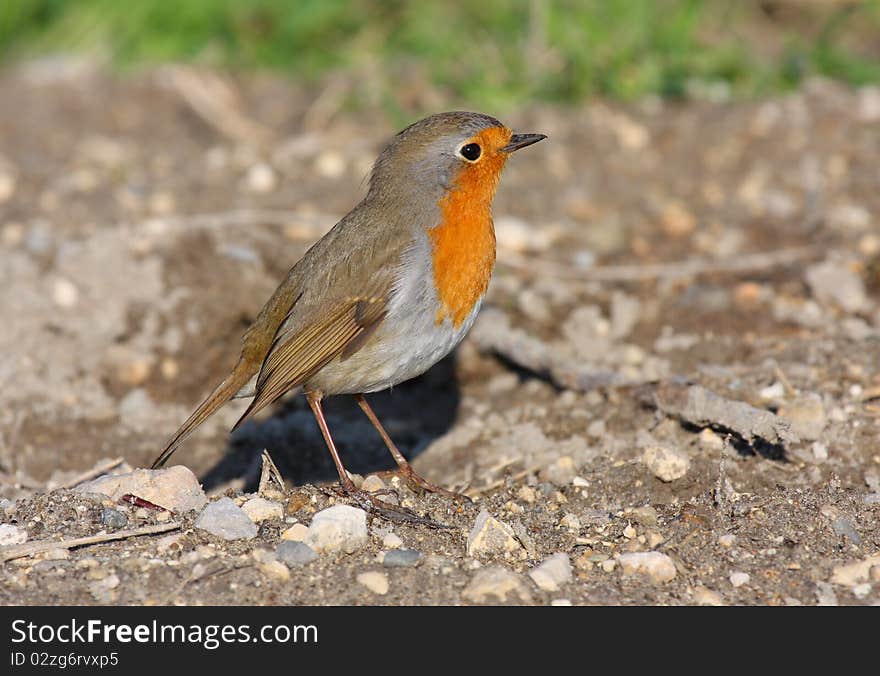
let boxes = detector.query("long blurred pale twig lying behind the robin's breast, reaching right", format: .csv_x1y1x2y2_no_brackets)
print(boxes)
498,246,826,282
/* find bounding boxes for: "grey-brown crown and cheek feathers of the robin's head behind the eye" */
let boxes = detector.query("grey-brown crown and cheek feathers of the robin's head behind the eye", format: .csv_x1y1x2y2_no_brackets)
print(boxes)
367,111,504,204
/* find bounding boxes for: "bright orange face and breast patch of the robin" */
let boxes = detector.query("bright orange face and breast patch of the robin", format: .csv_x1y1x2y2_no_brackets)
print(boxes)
429,127,511,328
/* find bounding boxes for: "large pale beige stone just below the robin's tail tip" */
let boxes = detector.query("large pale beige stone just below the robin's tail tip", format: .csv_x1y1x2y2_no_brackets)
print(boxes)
74,465,208,513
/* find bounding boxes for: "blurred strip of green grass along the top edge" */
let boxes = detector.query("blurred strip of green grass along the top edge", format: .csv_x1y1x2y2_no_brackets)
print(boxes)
0,0,880,109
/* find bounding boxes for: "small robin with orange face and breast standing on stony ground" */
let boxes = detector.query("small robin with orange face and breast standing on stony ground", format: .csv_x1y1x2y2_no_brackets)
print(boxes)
153,112,546,520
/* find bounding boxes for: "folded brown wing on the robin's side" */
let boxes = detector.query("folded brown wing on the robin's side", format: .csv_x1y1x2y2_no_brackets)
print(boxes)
233,268,393,429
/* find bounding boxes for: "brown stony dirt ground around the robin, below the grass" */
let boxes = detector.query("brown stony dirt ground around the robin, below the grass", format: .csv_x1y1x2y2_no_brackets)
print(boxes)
0,64,880,605
